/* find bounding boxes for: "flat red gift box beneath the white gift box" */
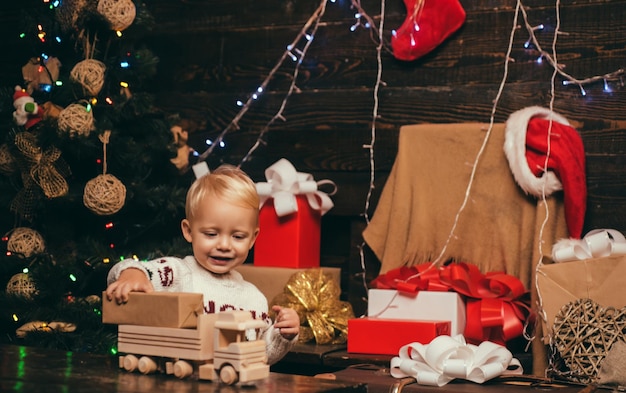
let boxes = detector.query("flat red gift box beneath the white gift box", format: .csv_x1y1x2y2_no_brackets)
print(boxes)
348,317,451,355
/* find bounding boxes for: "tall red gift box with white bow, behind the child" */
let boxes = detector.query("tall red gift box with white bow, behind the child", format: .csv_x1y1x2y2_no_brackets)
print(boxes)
254,158,336,268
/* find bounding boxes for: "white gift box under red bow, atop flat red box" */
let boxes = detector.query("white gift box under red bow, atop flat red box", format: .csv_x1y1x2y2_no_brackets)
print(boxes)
367,289,466,336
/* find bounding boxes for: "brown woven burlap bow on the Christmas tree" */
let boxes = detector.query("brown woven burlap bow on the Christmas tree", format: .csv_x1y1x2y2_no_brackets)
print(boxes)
11,132,70,218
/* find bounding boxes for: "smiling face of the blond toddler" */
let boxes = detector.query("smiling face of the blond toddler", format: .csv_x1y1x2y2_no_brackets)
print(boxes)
181,192,259,274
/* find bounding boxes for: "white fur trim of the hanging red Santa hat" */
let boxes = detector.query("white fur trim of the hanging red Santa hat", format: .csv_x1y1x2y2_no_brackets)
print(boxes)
504,106,570,197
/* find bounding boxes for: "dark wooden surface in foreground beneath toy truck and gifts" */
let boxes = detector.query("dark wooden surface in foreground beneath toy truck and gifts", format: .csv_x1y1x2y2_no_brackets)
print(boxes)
0,345,591,393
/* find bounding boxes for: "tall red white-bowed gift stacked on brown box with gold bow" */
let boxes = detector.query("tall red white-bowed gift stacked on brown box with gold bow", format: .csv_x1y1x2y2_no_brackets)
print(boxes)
244,159,354,344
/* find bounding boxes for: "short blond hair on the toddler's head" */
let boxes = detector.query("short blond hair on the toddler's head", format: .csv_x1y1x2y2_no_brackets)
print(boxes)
185,164,260,219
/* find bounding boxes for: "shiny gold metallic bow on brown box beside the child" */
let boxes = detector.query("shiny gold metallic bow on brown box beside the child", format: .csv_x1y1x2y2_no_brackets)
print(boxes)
272,269,354,344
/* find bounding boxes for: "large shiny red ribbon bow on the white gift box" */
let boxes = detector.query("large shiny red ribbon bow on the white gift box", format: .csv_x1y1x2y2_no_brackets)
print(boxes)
370,262,531,345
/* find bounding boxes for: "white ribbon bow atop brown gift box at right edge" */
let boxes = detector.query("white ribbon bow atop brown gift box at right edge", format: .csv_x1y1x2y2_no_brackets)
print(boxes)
552,229,626,262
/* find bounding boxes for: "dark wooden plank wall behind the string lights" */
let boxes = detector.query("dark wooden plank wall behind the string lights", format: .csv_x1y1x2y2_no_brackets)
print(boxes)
140,0,626,312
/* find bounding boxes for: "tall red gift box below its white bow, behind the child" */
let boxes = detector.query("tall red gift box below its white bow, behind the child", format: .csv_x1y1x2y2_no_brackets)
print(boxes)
253,195,321,268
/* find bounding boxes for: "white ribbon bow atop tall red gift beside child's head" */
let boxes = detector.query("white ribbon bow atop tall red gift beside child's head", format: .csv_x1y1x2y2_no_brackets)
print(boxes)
256,158,336,217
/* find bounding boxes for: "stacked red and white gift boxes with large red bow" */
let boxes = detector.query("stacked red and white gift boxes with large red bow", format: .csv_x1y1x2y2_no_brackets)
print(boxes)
348,263,530,355
